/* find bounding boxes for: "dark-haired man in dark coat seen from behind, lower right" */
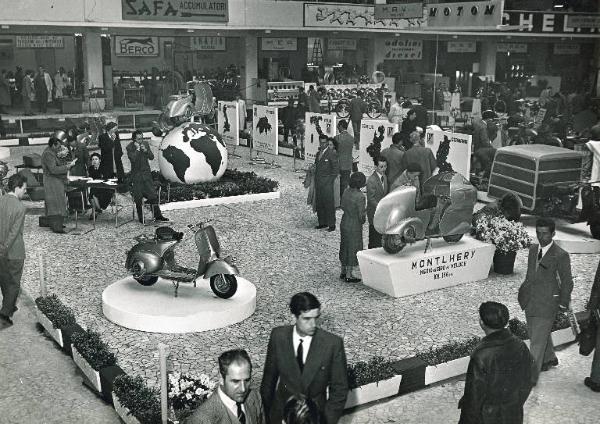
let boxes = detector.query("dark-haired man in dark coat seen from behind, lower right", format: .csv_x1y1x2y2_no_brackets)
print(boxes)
458,302,533,424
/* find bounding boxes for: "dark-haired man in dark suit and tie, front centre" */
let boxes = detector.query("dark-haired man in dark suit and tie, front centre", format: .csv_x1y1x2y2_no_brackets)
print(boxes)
260,292,348,424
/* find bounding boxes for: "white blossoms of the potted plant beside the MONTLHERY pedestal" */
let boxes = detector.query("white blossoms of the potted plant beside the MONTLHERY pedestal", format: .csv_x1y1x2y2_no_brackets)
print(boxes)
474,214,531,253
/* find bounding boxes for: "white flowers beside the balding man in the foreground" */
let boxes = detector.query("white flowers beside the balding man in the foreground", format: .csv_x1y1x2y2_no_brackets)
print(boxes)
168,372,217,420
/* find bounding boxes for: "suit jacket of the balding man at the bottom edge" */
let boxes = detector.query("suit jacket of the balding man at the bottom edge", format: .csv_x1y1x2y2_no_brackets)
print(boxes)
184,390,265,424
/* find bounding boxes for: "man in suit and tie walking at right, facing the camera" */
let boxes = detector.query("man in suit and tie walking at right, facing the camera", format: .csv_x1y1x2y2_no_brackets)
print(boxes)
519,218,573,385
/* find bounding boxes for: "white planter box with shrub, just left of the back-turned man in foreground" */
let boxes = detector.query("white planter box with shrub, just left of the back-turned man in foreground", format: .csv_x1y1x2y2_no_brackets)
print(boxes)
417,337,480,386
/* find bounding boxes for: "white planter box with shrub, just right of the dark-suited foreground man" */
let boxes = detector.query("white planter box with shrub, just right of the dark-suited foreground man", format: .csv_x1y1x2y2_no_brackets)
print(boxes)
345,356,402,409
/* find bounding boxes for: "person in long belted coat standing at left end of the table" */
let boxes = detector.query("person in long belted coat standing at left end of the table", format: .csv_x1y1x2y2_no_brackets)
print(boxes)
42,137,77,233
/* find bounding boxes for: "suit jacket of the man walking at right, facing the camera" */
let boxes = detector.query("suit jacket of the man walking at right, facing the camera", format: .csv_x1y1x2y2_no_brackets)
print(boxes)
519,243,573,318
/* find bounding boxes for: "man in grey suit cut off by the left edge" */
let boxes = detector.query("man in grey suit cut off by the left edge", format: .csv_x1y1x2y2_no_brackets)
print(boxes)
0,174,27,326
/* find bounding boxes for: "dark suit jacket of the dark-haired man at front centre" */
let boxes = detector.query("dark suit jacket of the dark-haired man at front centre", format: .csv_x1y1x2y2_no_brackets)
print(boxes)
260,325,348,424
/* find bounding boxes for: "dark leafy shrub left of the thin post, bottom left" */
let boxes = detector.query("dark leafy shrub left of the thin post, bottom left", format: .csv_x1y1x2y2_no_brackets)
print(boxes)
112,374,161,424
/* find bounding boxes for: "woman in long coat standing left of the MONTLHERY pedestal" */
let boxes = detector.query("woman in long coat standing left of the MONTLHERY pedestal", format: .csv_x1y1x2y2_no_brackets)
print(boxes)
340,172,367,283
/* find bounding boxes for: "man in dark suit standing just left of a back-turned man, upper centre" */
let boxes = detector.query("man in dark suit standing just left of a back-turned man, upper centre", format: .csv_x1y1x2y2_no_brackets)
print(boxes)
315,134,340,231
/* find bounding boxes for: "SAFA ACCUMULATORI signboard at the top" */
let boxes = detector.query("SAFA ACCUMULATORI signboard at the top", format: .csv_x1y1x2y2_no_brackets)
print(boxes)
121,0,229,22
